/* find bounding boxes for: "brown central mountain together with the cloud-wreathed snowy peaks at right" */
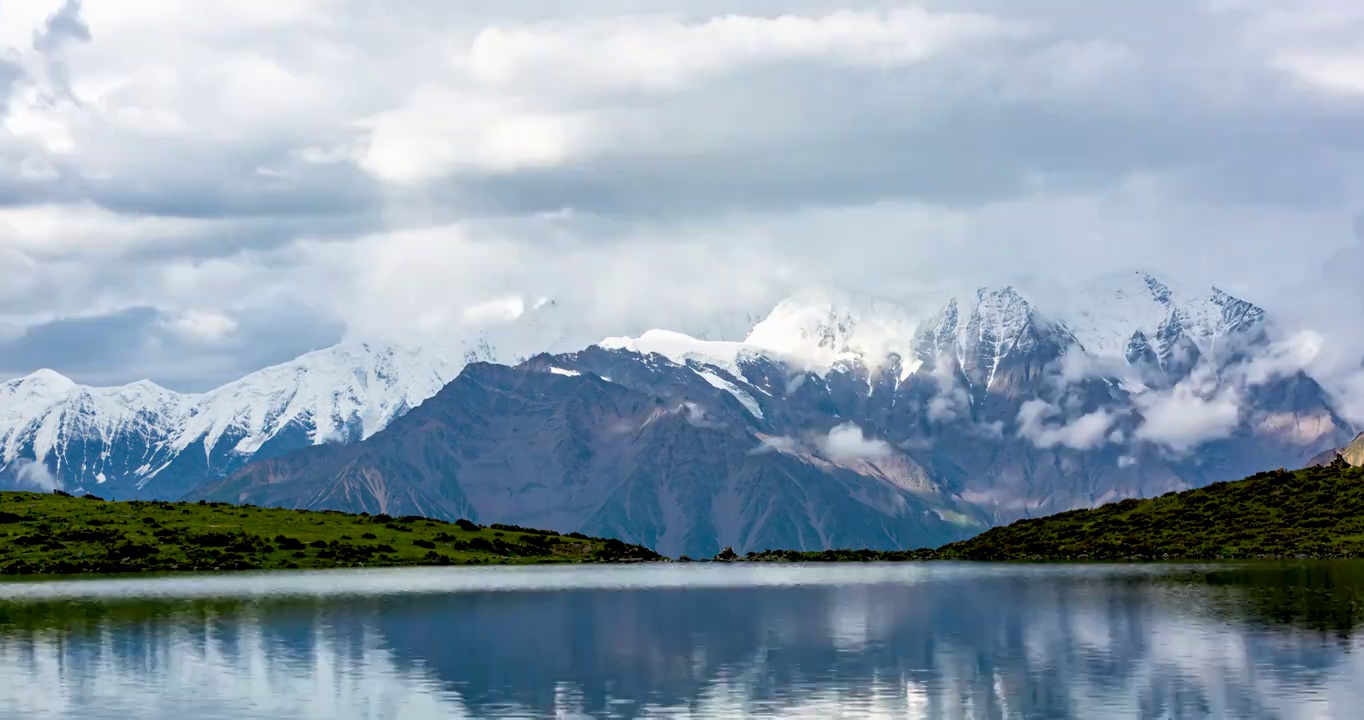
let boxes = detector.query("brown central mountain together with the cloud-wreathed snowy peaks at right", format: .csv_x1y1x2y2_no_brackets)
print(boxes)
192,274,1353,555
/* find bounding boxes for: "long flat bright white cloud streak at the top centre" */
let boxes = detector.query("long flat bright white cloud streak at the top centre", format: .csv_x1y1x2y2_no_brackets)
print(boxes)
461,7,1030,89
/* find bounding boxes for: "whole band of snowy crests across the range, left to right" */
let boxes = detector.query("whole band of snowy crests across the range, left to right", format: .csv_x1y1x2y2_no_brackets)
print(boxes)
0,273,1282,499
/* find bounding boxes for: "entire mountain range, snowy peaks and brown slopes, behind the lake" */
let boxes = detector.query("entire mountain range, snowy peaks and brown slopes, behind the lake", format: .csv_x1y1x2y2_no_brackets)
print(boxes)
0,273,1354,556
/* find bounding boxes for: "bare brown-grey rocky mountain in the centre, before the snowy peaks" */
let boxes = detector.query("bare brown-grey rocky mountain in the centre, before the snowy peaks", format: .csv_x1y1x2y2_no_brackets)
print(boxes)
198,362,982,556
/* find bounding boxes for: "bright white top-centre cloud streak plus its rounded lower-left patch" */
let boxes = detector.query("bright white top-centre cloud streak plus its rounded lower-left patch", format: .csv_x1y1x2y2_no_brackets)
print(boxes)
359,8,1024,184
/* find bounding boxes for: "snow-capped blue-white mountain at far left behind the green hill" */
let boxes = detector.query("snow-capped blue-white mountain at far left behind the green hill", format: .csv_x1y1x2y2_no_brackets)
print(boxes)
0,344,457,498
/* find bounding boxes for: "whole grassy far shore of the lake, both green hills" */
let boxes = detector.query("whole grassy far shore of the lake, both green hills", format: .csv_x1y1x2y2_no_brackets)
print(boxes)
8,462,1364,580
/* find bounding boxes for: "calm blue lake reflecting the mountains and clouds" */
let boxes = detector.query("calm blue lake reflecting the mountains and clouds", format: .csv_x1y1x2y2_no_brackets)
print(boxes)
0,563,1364,720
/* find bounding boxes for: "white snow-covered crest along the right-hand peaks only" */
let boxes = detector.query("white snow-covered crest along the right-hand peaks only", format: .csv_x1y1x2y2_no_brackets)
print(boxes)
597,273,1264,387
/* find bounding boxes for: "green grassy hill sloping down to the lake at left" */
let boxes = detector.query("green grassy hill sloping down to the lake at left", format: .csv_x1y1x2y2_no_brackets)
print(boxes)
0,492,659,575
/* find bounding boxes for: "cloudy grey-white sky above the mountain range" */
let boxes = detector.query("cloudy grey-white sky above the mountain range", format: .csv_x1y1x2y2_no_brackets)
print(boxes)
0,0,1364,398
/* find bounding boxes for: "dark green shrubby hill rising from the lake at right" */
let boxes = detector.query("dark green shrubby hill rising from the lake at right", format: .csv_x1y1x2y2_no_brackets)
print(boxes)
749,462,1364,562
